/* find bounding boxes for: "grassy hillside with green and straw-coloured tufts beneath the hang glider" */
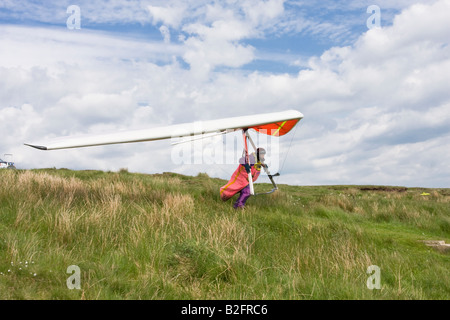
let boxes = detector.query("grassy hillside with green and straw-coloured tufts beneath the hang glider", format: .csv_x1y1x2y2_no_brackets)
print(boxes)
0,169,450,300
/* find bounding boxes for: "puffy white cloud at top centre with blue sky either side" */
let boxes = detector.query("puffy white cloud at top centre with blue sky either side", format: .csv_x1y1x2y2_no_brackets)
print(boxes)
148,0,284,79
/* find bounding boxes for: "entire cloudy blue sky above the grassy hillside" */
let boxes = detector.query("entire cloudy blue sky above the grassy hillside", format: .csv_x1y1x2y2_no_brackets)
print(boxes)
0,0,450,187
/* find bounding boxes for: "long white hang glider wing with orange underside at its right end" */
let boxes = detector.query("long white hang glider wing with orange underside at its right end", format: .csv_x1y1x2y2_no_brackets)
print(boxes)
25,110,303,150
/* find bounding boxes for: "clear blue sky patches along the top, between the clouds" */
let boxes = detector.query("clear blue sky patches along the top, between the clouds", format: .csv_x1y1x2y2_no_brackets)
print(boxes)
0,1,398,73
